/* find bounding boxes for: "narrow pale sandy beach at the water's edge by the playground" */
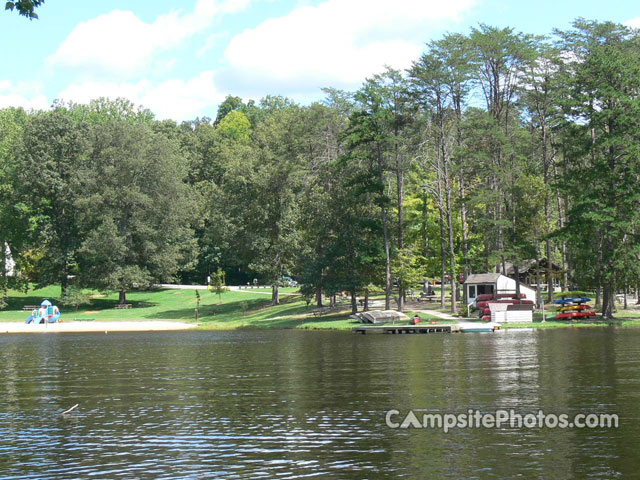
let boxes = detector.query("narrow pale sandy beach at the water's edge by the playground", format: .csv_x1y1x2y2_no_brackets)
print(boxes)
0,321,197,333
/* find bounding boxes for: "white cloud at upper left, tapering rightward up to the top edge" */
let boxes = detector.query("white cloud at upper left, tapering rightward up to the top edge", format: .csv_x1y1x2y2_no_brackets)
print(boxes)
47,0,249,78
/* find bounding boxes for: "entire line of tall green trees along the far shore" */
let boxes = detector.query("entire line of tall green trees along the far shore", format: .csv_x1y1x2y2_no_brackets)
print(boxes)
0,19,640,317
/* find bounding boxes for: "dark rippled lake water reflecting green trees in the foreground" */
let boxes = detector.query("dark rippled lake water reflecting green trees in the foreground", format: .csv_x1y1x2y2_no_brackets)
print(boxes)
0,329,640,479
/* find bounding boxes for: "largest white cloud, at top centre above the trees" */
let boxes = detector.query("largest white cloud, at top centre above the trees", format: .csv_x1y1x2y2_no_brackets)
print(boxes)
225,0,475,89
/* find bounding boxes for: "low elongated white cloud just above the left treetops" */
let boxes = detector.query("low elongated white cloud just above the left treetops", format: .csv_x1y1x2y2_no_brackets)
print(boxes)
59,70,224,121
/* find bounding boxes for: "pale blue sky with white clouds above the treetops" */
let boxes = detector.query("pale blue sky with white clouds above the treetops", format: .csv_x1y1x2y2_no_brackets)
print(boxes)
0,0,640,122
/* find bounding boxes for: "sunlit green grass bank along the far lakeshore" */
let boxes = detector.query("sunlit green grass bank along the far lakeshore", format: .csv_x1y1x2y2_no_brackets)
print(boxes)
0,287,640,330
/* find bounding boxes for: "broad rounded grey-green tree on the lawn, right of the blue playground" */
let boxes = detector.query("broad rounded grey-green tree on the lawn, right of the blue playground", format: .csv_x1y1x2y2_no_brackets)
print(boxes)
77,112,195,300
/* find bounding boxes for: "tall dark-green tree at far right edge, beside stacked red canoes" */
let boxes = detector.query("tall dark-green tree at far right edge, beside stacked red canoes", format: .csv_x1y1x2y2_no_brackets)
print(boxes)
561,20,640,318
